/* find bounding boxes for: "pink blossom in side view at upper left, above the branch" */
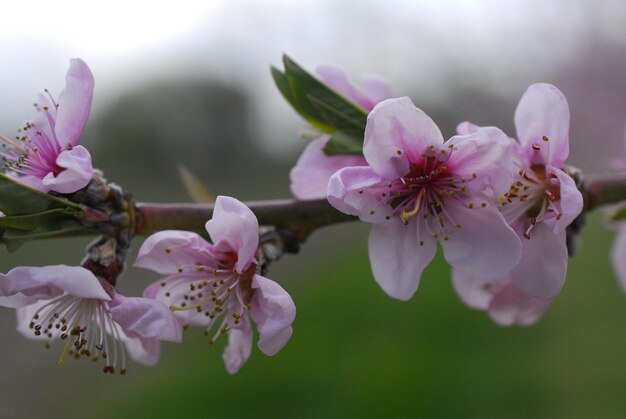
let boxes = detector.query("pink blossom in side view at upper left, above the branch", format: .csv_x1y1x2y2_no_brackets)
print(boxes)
0,59,94,193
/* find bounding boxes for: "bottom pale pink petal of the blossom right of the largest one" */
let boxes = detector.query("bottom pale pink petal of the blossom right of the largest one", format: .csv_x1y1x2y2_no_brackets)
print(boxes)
511,223,567,300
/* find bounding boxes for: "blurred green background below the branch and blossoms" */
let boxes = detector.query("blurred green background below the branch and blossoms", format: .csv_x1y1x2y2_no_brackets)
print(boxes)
80,217,626,418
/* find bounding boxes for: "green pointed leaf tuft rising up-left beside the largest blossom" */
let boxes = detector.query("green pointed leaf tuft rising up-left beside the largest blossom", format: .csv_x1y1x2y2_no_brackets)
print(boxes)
271,55,367,145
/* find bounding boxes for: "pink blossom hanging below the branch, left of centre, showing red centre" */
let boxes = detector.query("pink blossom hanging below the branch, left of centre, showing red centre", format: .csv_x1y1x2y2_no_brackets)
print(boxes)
135,196,296,374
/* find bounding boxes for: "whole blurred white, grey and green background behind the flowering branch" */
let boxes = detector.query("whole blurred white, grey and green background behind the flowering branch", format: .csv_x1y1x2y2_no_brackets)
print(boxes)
0,0,626,418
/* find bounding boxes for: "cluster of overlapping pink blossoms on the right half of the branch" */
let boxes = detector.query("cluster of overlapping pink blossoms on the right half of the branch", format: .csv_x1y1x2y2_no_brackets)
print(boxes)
291,70,583,325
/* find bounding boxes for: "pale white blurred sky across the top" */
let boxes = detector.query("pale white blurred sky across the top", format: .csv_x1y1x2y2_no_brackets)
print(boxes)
0,0,626,167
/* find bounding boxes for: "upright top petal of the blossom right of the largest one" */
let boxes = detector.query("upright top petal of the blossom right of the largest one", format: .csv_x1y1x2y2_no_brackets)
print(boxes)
515,83,570,167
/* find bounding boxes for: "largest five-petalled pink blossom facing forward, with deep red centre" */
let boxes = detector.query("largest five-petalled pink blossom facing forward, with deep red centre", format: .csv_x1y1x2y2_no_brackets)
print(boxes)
328,98,521,300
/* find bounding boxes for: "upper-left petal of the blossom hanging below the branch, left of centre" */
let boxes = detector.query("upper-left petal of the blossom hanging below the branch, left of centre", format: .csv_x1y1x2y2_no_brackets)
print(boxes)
134,230,215,274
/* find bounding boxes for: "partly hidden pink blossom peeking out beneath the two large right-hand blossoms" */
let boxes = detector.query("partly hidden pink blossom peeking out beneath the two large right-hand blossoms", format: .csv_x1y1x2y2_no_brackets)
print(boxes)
452,269,551,326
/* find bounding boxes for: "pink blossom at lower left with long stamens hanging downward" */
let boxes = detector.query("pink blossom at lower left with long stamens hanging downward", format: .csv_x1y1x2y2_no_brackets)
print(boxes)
0,265,182,374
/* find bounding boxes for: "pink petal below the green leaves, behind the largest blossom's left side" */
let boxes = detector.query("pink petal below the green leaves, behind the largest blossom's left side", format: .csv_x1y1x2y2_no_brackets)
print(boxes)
289,135,367,200
